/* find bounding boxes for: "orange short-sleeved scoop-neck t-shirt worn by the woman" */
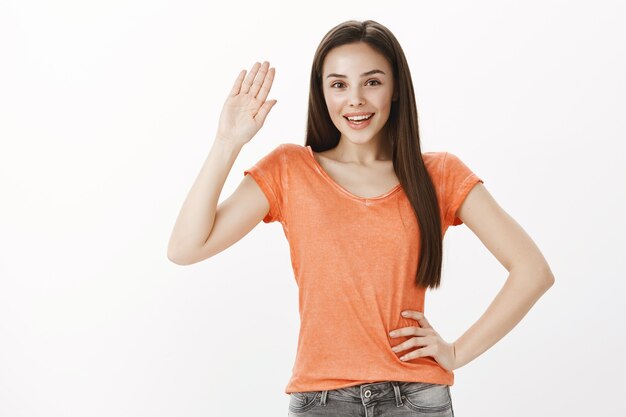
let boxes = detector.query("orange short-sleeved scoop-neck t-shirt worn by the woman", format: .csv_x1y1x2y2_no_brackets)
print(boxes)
244,143,483,394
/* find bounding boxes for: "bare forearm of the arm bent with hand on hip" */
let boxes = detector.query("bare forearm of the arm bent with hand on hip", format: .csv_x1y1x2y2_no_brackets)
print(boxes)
453,267,554,369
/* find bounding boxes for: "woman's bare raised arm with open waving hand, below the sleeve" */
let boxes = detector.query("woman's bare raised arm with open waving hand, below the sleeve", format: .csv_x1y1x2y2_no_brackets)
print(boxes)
167,62,276,265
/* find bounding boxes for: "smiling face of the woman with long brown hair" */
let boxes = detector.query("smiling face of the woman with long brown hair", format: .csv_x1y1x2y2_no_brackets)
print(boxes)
322,42,394,144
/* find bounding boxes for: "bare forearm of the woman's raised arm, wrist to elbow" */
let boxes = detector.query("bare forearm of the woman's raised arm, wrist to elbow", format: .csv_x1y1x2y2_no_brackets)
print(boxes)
168,138,241,260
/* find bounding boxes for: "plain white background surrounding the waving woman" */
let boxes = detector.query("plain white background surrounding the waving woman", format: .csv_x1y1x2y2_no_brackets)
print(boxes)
0,0,626,417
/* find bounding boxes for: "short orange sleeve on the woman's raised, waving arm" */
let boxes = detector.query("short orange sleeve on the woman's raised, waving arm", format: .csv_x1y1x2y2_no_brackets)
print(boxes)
243,144,285,223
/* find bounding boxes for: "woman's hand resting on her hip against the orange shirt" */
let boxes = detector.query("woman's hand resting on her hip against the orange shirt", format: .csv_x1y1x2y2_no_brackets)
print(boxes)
389,310,456,371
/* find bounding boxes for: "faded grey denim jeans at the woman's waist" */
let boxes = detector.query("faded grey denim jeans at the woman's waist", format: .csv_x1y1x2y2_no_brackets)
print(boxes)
288,381,454,417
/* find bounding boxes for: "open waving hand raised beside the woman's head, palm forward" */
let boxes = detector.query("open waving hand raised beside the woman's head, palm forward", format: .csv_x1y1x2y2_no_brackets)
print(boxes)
217,61,276,146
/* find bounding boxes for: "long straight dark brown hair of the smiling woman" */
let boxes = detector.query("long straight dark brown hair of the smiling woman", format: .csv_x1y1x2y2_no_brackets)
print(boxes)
305,20,443,288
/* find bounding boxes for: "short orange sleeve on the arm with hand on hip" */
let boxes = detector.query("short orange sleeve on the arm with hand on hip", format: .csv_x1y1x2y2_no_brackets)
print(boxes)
442,152,484,226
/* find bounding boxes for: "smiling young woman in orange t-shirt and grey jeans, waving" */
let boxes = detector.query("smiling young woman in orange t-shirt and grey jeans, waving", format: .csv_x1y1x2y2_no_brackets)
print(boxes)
168,20,554,416
